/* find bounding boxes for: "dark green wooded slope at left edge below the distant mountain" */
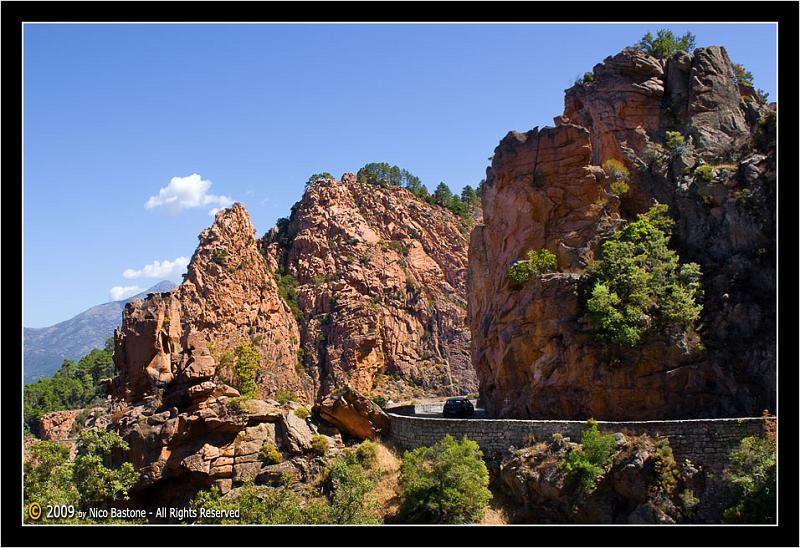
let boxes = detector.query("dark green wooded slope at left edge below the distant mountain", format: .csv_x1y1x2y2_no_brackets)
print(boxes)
23,339,114,433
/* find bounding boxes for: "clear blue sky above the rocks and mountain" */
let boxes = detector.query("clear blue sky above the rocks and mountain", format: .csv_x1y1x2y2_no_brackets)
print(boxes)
23,23,777,327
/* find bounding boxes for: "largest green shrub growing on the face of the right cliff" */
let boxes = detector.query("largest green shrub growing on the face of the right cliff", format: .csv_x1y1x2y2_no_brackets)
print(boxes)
586,204,702,347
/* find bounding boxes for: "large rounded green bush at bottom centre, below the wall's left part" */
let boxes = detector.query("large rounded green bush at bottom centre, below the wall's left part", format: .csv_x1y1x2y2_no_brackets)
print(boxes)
398,435,492,523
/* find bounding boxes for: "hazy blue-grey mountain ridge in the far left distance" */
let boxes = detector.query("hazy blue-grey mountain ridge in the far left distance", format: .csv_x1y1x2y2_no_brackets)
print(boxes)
23,280,175,384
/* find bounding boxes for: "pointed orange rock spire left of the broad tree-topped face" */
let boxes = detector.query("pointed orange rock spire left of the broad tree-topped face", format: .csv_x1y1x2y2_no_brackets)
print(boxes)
114,204,314,402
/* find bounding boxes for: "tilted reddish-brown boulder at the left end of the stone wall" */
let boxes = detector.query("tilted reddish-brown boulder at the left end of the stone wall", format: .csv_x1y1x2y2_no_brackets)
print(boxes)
314,387,390,440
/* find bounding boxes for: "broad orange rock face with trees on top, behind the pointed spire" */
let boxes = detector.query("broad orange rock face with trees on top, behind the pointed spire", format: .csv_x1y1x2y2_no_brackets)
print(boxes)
262,178,477,398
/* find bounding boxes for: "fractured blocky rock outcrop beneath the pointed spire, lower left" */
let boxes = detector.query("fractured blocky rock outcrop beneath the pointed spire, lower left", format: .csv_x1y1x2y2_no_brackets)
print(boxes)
114,390,342,506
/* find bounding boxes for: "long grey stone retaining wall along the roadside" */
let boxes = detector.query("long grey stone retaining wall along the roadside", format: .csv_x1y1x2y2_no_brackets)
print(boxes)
387,414,775,473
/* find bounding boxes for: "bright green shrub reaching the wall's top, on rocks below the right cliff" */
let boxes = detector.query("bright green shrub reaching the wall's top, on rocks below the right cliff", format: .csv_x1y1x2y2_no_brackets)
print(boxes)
561,419,616,493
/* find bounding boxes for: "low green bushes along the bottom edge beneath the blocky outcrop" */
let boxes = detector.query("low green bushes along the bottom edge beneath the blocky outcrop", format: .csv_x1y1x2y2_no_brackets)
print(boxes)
190,441,381,524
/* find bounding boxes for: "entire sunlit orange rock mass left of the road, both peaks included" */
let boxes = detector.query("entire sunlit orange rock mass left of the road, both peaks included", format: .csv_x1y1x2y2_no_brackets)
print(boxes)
109,177,477,505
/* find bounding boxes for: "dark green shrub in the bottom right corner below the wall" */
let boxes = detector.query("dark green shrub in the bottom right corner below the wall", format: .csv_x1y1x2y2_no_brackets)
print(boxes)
723,436,777,523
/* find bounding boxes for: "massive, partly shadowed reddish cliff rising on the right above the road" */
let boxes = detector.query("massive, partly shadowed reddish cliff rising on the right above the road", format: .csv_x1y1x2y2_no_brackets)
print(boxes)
469,47,775,419
